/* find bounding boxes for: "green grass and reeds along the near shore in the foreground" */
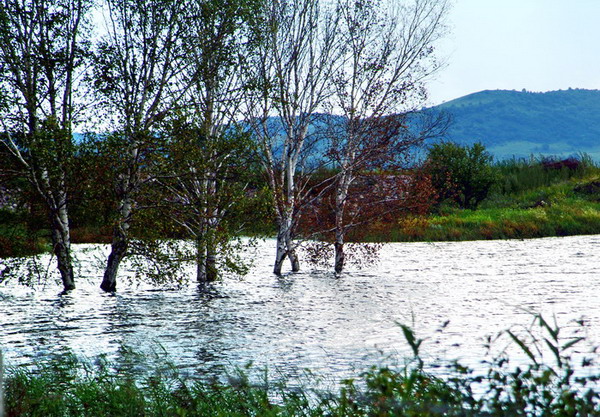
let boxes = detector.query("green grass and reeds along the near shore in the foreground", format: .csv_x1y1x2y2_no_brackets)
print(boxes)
4,316,600,417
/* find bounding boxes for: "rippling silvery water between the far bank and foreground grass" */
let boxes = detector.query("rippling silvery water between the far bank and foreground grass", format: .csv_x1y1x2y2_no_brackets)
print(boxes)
0,236,600,380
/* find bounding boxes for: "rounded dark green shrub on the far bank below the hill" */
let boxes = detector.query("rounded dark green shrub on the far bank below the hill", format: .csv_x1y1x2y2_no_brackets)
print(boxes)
425,142,496,209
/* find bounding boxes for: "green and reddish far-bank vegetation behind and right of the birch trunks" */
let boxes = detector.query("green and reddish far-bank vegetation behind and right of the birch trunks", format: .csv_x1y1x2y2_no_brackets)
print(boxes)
0,144,600,280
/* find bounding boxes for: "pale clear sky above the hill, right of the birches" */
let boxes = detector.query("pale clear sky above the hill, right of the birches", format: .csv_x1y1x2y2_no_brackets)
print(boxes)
429,0,600,104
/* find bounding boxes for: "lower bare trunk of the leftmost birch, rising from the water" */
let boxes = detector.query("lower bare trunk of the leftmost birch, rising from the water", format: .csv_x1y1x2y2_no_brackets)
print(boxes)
50,204,75,292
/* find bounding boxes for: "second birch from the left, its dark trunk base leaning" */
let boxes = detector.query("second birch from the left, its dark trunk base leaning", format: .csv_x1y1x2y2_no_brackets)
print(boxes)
94,0,185,291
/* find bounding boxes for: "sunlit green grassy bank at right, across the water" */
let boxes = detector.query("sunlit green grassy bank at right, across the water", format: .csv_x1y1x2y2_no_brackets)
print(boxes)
367,156,600,242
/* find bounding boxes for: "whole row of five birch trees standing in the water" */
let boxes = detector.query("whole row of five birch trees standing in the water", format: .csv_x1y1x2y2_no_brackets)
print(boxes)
0,0,447,291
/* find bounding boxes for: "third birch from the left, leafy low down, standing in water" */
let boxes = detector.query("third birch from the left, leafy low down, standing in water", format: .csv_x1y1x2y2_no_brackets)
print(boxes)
161,0,260,282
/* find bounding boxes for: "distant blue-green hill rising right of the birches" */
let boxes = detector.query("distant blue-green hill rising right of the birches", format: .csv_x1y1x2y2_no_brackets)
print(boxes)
435,89,600,160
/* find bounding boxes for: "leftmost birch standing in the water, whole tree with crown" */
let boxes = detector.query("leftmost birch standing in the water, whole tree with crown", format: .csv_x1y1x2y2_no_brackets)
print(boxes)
0,0,91,291
